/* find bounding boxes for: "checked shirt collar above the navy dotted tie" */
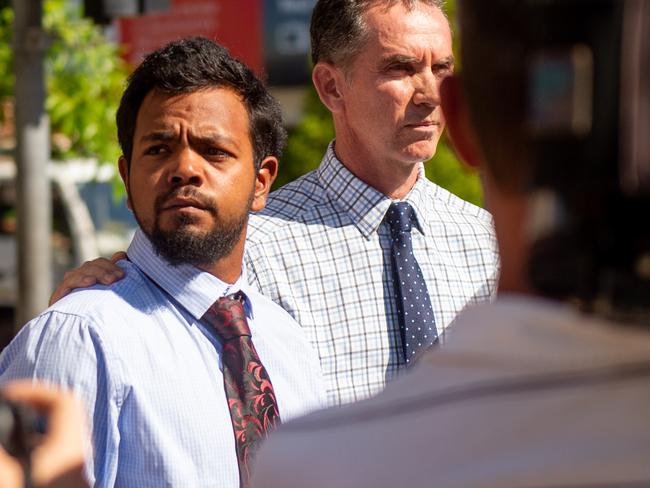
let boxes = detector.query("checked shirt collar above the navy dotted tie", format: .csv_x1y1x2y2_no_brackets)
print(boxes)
318,141,427,239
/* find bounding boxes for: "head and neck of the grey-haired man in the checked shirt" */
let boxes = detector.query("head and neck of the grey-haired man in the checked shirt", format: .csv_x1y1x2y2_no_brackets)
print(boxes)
311,0,453,196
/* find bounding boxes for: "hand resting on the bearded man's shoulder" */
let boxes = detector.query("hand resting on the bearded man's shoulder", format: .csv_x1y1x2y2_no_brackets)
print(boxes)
49,251,126,305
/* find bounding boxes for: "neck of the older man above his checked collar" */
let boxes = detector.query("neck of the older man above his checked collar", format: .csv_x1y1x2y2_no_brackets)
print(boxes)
334,131,420,200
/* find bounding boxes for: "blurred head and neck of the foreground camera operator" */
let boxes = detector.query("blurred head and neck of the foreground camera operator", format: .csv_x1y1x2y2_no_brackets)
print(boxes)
442,0,576,292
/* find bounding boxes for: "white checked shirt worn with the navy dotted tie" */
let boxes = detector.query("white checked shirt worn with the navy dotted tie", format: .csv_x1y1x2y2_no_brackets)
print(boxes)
245,143,498,405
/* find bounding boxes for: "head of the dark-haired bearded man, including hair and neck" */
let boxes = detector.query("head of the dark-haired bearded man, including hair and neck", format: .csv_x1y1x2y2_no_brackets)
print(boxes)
117,38,286,280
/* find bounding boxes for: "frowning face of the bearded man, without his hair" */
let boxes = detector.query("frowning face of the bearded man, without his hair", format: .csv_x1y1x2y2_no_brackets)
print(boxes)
127,88,255,265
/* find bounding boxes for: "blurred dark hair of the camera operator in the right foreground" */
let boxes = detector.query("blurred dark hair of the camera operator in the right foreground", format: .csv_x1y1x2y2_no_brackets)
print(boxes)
458,0,531,193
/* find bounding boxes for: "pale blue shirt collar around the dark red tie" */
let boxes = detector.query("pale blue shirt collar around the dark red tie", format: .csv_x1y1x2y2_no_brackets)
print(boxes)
127,229,253,320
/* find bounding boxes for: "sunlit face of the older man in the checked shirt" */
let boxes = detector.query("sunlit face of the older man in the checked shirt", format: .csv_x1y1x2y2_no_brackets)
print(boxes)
337,3,453,170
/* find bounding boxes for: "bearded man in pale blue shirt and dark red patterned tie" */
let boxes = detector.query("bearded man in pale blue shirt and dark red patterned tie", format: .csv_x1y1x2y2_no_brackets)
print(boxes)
0,38,325,488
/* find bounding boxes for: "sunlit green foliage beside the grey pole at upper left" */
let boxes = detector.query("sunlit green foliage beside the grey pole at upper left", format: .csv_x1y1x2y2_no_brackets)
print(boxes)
0,0,127,163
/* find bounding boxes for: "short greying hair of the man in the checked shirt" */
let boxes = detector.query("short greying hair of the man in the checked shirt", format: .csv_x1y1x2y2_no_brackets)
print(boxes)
310,0,444,68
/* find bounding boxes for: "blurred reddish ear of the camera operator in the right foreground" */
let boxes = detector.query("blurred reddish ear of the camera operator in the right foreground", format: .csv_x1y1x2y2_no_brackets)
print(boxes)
440,75,481,169
